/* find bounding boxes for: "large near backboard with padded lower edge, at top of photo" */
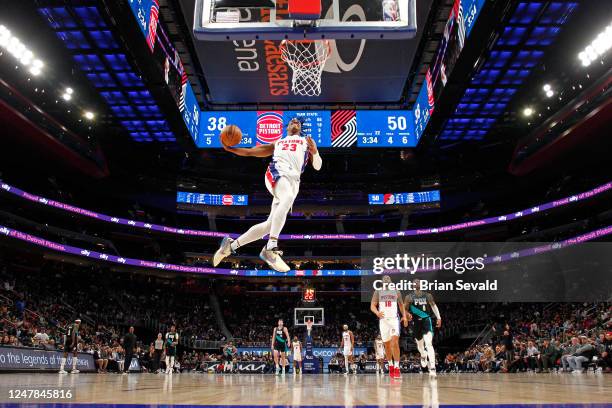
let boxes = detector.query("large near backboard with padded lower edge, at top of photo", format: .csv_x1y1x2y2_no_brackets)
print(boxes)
193,0,417,41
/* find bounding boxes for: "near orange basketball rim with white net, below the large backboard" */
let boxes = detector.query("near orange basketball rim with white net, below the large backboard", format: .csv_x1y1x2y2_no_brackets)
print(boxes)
280,40,331,96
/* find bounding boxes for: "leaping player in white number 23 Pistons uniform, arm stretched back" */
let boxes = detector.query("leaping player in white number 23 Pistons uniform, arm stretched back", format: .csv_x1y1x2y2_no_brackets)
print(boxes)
213,118,323,272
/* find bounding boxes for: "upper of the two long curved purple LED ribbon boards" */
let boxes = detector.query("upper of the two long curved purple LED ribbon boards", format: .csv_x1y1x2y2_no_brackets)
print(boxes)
0,182,612,241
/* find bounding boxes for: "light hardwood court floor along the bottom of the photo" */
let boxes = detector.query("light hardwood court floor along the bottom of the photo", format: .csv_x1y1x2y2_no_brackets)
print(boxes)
0,373,612,406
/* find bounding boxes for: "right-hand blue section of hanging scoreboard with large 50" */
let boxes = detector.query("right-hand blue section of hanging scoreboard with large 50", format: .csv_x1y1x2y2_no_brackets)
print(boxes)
357,110,416,147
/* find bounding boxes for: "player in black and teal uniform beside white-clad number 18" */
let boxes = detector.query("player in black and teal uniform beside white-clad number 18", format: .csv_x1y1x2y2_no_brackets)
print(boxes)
404,279,442,377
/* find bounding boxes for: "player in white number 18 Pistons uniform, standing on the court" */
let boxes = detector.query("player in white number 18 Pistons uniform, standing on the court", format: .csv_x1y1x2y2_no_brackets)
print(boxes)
370,275,408,378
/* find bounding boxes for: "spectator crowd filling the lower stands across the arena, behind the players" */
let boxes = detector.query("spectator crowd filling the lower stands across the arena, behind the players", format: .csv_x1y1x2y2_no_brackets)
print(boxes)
0,256,612,372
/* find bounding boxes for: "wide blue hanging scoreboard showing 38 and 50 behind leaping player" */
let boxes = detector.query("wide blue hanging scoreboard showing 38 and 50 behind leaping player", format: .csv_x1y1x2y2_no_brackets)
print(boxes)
195,110,417,148
